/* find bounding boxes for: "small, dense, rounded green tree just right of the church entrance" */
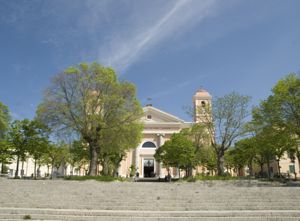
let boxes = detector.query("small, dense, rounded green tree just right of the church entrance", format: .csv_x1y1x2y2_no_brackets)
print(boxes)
154,133,199,176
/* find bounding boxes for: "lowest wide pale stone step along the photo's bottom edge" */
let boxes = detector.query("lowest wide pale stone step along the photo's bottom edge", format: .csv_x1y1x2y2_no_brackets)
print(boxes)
0,208,300,221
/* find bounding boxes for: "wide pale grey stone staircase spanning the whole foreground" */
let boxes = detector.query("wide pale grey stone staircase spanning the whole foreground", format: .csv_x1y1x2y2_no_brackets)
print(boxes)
0,178,300,221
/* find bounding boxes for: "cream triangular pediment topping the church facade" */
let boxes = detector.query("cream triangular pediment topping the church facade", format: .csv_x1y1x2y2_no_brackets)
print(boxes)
141,106,184,123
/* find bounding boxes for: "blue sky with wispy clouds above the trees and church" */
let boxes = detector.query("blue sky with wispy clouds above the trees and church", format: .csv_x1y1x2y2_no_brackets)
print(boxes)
0,0,300,120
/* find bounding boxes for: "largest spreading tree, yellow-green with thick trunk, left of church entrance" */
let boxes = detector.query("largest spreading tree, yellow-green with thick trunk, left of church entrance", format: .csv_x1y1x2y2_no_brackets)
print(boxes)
37,63,142,175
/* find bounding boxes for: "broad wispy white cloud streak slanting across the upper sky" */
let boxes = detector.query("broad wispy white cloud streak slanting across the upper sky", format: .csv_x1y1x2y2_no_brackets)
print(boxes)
99,0,217,73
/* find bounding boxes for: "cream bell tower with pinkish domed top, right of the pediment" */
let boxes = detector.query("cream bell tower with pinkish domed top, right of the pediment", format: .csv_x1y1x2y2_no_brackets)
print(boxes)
193,88,212,123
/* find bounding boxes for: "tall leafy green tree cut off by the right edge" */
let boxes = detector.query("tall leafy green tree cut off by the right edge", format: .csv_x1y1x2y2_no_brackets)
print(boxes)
253,74,300,174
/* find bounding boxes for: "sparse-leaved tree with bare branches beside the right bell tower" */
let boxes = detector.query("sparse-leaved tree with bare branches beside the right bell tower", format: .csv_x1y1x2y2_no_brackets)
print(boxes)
200,92,250,176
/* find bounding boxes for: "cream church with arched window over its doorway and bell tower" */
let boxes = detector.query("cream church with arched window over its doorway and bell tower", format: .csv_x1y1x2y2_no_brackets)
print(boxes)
119,89,212,178
